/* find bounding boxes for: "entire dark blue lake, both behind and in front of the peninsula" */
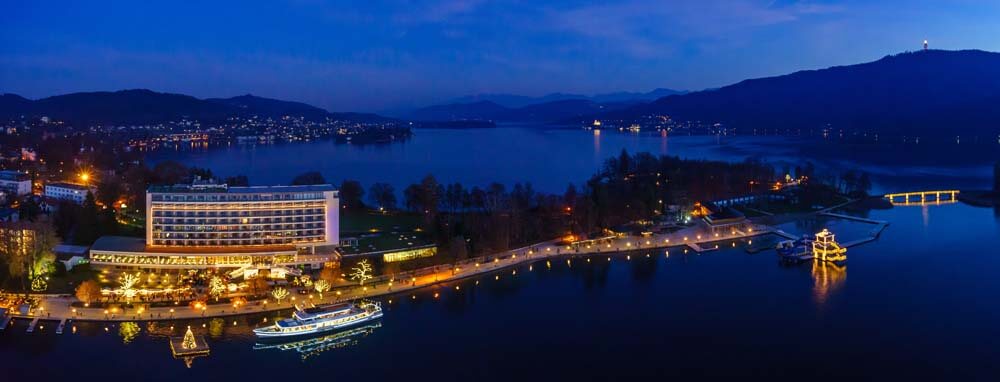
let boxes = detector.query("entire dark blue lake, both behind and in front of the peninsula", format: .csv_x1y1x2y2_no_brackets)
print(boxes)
0,127,1000,381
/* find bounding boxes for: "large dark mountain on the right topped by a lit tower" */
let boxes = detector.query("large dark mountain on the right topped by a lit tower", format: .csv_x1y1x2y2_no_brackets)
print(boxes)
608,50,1000,139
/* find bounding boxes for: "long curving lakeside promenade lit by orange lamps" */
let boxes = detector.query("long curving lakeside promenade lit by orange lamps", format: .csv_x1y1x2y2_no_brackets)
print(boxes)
7,222,772,322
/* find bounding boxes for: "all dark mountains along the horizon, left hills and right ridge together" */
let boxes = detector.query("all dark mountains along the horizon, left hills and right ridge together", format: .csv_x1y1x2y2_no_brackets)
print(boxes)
0,50,1000,139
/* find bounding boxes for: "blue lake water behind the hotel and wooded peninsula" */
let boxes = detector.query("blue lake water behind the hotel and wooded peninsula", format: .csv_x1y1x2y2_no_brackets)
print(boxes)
147,127,1000,193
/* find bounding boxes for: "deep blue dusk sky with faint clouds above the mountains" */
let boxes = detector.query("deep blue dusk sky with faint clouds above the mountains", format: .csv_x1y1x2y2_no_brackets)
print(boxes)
0,0,1000,111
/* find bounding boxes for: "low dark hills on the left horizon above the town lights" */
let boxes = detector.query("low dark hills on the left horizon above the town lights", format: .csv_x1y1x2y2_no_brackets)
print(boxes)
0,89,387,124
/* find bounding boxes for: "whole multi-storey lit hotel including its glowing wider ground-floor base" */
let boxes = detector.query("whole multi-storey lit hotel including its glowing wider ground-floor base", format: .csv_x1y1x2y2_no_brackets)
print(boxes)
90,182,340,277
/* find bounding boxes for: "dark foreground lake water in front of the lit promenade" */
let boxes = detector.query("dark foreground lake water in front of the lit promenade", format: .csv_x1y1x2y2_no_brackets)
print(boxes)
0,204,1000,381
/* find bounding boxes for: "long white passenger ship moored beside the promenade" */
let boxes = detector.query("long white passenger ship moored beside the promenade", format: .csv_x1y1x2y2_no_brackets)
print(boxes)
253,302,382,338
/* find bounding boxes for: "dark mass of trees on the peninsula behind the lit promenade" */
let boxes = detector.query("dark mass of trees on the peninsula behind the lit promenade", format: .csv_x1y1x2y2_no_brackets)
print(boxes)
394,151,774,254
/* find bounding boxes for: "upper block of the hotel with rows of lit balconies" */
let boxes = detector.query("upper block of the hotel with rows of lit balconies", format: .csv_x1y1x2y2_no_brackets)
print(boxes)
146,184,340,248
